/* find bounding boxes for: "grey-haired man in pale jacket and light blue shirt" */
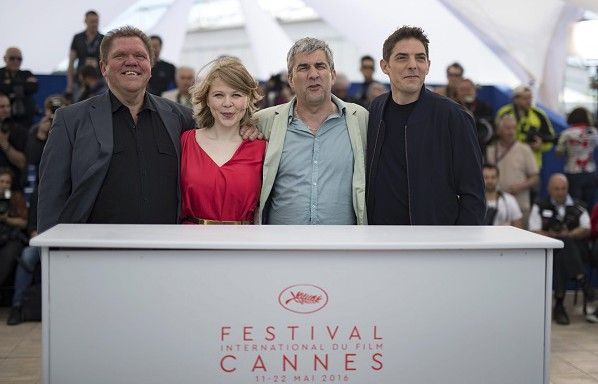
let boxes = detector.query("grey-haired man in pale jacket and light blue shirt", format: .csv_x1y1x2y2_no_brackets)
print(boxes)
256,38,368,225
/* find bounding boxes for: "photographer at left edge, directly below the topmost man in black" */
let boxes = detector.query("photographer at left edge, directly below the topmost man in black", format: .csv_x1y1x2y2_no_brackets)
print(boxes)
0,93,27,191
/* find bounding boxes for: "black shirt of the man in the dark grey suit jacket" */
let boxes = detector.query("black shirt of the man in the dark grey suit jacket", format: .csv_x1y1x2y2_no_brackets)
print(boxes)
88,92,178,224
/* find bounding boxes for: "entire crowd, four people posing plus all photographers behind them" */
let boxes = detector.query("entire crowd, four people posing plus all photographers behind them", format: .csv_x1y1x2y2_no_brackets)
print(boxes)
0,11,598,325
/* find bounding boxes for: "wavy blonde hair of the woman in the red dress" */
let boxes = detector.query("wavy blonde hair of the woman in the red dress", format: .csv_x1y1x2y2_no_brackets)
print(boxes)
190,57,262,128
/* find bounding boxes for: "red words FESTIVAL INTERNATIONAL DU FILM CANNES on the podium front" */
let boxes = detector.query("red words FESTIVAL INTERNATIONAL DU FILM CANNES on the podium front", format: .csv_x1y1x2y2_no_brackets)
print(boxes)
220,325,384,373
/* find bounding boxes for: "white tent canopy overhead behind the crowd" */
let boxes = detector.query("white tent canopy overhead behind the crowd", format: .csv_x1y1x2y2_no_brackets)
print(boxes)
0,0,598,107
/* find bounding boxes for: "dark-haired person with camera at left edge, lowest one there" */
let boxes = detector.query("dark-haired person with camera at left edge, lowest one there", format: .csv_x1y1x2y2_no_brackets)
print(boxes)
0,167,27,308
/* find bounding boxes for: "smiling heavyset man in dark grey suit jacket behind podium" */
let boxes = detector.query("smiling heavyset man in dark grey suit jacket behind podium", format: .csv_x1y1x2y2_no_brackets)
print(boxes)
38,26,195,232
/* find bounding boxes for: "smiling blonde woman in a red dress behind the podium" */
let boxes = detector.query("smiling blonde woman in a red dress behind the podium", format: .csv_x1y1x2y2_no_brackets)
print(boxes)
181,57,266,224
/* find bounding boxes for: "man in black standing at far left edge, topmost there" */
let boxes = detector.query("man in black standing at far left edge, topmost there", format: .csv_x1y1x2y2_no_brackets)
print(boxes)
0,47,38,127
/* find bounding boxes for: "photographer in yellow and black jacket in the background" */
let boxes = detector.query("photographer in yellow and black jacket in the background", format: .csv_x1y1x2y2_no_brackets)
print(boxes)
496,85,555,169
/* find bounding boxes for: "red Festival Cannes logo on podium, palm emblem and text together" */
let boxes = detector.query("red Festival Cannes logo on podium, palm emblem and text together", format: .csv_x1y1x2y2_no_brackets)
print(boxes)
218,284,384,383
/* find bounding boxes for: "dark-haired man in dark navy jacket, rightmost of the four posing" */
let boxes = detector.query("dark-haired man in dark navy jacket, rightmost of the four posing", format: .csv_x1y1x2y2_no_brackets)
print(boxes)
366,26,486,225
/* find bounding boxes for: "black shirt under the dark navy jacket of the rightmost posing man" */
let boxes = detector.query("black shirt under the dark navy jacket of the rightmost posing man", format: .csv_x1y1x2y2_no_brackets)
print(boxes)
370,97,417,225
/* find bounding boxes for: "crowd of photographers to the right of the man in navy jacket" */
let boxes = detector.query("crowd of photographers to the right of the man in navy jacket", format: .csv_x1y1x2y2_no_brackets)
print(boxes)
436,63,598,325
